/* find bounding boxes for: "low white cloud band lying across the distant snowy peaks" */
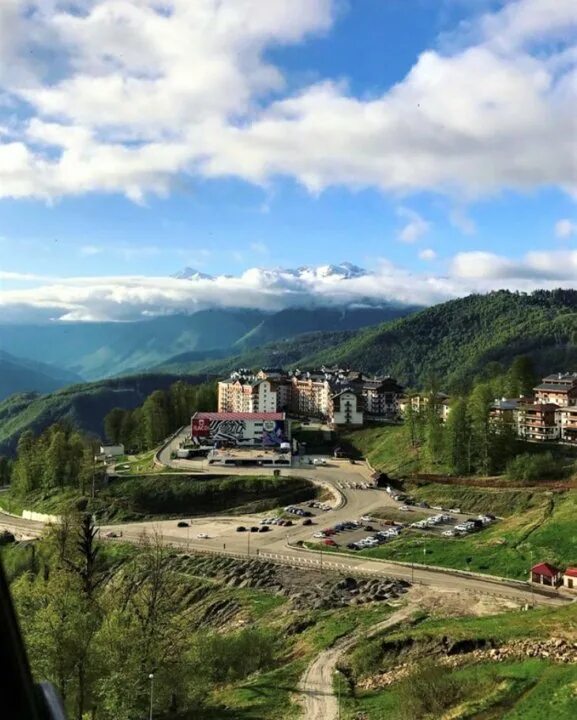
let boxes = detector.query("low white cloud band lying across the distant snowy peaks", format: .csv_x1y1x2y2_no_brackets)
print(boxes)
0,251,577,322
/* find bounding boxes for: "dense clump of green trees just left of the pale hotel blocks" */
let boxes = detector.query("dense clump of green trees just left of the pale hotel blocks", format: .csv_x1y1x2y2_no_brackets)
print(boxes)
104,380,217,453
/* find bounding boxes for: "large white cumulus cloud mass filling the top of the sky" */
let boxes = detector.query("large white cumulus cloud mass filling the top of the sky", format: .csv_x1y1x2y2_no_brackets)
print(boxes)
0,0,577,202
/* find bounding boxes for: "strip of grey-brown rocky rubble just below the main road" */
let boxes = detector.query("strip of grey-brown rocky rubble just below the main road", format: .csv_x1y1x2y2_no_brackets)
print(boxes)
173,556,409,610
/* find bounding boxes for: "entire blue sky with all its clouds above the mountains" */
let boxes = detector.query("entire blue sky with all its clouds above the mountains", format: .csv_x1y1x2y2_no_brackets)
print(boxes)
0,0,577,322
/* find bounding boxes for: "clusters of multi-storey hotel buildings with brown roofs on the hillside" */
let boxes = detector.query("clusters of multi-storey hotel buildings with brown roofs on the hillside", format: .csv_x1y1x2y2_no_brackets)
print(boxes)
218,367,577,444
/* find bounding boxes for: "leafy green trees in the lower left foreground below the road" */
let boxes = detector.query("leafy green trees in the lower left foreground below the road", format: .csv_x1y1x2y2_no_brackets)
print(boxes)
11,513,276,720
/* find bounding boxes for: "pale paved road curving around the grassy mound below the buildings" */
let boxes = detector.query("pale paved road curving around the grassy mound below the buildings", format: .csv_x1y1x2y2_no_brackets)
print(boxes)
0,437,570,605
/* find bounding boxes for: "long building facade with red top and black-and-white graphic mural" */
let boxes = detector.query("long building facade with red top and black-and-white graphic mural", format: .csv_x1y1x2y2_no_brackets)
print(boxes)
191,413,289,448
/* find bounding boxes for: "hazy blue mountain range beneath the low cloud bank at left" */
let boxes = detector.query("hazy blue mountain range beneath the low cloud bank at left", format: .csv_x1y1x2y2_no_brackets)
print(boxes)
0,306,415,392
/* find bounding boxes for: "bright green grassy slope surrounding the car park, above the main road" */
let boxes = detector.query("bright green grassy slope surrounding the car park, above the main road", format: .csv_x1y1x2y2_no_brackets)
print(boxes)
336,426,577,579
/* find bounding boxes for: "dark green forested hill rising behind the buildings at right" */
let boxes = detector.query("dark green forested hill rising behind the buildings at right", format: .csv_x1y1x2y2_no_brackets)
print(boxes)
306,290,577,389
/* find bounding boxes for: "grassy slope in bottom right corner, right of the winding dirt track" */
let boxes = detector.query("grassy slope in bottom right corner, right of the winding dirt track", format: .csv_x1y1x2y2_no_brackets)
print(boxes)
343,605,577,720
